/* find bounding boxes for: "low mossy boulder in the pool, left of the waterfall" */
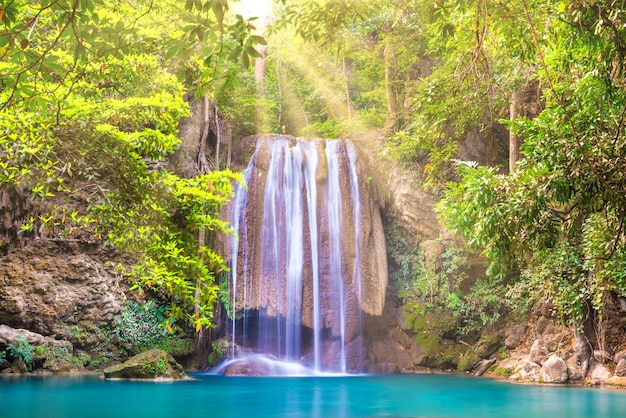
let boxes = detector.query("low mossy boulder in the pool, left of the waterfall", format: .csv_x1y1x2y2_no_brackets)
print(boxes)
104,350,189,380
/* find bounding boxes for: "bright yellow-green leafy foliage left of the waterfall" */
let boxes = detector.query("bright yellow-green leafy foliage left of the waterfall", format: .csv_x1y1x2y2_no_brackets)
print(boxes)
0,0,264,330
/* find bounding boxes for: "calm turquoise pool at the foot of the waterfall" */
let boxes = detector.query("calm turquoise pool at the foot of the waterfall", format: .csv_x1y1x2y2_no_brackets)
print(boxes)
0,374,626,418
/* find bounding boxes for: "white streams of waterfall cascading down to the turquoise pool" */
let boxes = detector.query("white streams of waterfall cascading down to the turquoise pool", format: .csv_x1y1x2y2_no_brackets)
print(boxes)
222,136,370,373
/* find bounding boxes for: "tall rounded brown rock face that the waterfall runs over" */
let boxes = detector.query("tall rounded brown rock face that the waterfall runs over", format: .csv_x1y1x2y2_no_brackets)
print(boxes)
227,135,387,370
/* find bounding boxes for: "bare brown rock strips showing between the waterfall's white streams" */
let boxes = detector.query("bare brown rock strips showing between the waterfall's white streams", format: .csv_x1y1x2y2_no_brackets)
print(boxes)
231,136,387,316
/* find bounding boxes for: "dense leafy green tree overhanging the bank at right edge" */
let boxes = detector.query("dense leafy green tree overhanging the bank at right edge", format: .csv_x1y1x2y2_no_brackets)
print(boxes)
439,3,626,345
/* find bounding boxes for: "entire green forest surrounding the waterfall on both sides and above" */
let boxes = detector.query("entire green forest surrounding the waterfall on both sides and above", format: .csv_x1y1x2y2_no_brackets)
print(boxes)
0,0,626,360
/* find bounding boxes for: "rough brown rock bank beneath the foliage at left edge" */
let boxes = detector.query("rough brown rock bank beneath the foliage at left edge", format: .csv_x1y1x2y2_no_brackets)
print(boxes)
0,239,127,339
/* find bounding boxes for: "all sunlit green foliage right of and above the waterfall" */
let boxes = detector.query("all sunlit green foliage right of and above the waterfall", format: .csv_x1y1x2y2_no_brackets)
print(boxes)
258,0,626,345
